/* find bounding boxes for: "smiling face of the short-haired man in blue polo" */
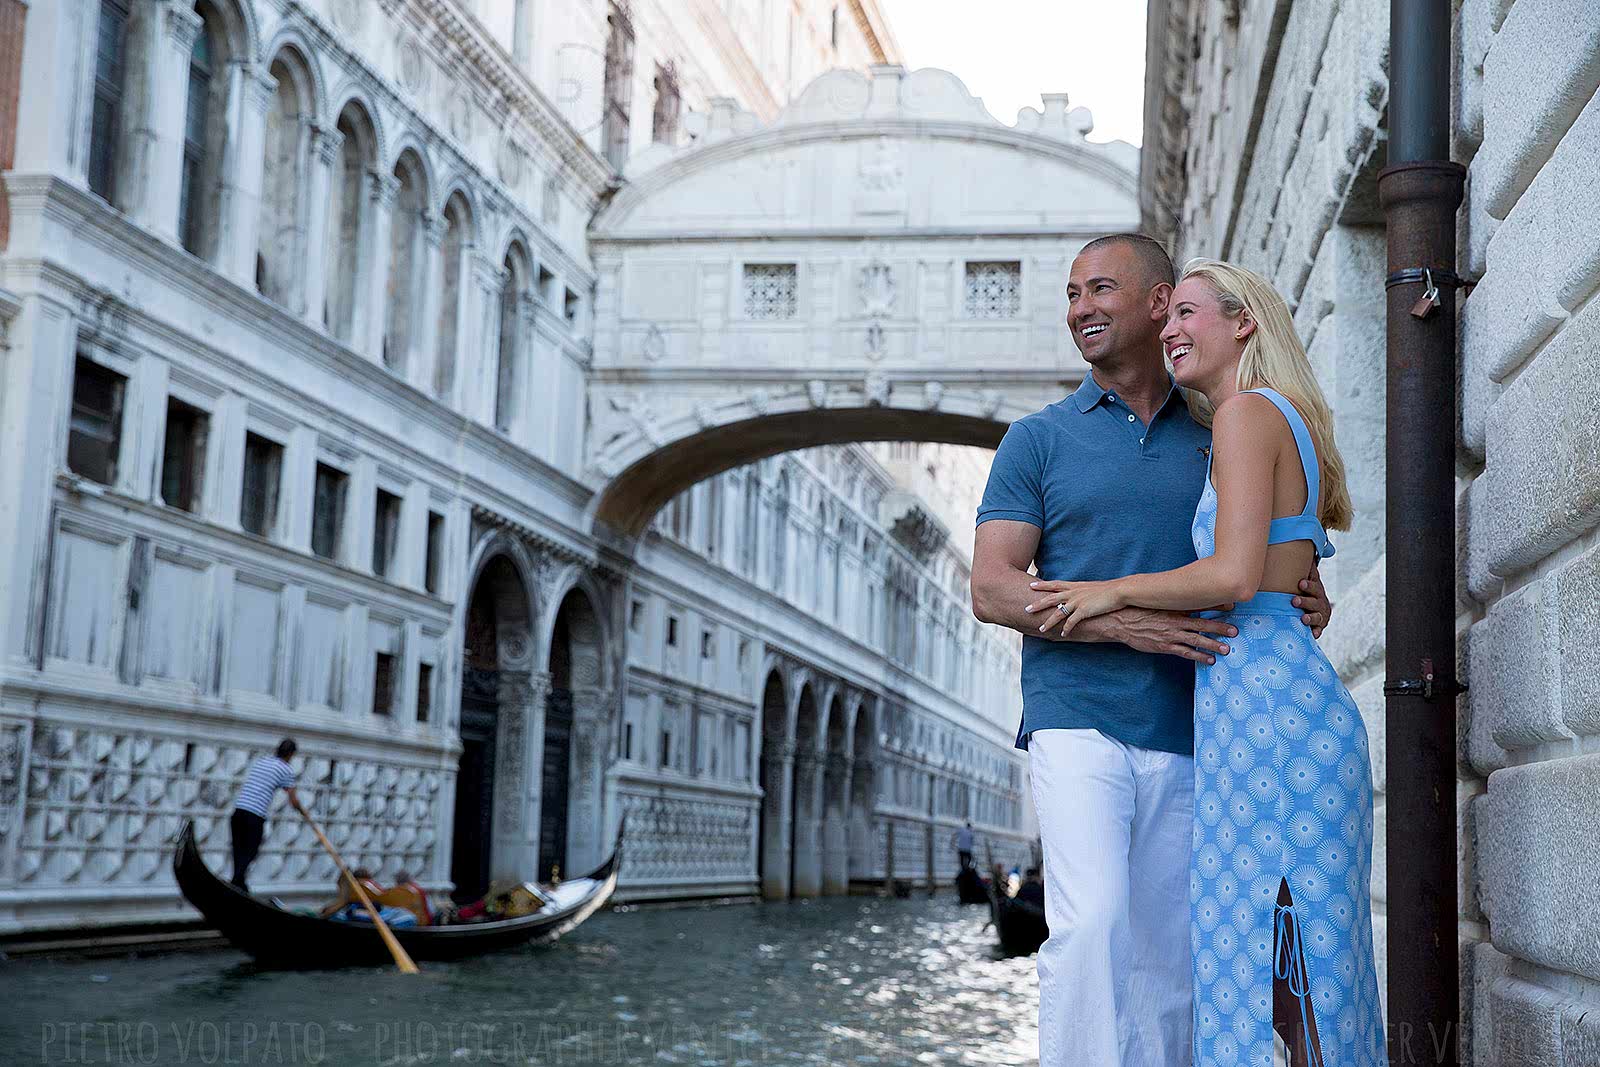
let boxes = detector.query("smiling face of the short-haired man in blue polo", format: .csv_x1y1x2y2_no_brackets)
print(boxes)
1067,243,1166,366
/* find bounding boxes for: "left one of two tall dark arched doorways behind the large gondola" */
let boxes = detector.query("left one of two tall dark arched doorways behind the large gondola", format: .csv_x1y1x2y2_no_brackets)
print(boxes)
451,536,534,899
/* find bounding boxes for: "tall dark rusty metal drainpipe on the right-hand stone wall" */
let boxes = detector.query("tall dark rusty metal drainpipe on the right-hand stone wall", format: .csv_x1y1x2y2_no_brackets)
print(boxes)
1378,0,1466,1064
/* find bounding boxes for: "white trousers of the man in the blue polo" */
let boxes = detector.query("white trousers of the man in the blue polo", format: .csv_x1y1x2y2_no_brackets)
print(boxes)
1027,729,1194,1067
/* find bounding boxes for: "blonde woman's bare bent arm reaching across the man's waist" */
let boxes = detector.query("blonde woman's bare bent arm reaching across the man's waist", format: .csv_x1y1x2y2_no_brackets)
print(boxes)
1027,394,1283,633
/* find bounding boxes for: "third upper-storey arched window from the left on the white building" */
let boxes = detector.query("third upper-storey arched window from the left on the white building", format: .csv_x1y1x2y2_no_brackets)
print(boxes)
256,50,314,310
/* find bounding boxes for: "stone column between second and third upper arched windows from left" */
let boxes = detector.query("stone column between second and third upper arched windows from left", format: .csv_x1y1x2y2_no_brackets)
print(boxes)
218,62,276,290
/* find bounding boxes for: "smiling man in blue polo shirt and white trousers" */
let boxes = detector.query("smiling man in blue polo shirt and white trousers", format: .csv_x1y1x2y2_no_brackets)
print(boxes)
973,234,1330,1067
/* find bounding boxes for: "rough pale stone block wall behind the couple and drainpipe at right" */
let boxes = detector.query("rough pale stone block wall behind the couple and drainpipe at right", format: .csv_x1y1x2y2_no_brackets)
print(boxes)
1141,0,1600,1065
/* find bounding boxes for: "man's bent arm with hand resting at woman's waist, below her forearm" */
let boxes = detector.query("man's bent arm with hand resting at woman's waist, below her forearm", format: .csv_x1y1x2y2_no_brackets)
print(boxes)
973,518,1237,664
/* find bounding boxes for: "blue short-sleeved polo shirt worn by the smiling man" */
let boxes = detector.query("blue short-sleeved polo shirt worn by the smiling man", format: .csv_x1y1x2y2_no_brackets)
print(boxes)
978,374,1211,755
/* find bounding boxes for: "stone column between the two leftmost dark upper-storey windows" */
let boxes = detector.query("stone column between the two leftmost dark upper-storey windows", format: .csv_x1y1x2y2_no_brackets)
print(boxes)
134,0,203,242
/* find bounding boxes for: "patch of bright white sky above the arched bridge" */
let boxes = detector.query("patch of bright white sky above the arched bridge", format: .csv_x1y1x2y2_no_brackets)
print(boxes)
878,0,1146,144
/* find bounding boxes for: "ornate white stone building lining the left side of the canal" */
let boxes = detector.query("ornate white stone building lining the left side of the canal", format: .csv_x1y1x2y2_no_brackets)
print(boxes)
0,0,1113,931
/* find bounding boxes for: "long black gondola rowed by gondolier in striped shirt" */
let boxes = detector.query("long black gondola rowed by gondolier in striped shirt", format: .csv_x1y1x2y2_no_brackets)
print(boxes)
173,822,622,969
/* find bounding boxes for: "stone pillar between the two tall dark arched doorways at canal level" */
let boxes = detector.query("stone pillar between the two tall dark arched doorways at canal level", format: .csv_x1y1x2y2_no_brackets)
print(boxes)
490,668,550,881
